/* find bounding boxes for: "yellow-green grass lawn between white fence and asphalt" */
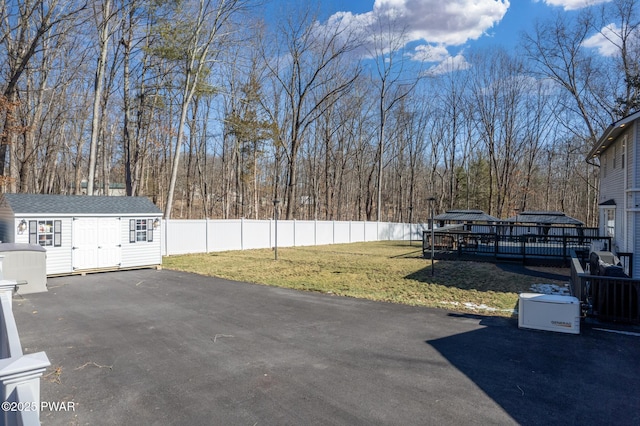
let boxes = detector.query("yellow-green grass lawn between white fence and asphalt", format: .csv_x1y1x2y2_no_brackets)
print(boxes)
163,241,568,316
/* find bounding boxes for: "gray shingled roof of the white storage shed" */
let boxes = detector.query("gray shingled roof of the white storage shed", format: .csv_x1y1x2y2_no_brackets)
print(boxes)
2,194,162,215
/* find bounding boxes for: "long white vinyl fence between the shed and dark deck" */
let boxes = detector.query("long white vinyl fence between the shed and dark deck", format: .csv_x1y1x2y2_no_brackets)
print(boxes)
162,219,428,256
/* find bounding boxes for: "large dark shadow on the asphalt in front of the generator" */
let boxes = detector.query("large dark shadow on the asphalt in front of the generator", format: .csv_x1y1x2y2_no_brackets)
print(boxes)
426,314,640,425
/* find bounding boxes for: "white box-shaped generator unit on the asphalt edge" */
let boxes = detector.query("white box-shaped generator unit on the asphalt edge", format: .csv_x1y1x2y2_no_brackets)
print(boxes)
518,293,580,334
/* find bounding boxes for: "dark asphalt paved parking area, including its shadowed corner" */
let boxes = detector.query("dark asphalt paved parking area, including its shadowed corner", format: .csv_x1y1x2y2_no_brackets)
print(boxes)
14,270,640,425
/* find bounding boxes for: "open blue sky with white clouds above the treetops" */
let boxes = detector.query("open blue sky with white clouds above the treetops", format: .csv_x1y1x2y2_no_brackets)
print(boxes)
288,0,610,72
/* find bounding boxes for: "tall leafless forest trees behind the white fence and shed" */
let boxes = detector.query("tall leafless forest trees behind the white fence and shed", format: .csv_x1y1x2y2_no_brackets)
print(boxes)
0,0,640,225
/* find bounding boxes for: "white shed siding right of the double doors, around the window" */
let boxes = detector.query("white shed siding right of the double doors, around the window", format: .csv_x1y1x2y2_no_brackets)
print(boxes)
120,215,162,268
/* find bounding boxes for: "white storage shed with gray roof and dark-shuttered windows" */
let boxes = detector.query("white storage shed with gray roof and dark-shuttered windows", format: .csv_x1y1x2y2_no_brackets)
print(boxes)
0,194,162,276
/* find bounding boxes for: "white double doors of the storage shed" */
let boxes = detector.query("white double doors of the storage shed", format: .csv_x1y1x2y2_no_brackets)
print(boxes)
72,217,122,270
